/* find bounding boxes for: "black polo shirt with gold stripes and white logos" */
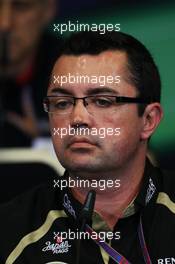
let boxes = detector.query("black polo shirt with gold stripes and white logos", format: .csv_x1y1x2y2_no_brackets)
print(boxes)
0,161,175,264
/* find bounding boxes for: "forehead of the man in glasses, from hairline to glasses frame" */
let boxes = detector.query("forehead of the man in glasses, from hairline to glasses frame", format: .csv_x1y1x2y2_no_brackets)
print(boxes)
48,51,137,96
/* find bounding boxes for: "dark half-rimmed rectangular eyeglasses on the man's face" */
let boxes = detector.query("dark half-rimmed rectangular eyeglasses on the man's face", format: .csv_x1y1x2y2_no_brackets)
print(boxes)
43,95,152,115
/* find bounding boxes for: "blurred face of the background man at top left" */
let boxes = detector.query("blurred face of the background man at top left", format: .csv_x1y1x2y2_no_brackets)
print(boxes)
0,0,52,64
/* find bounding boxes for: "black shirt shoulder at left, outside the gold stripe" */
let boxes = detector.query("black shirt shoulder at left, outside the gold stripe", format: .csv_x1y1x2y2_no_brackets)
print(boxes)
0,184,62,257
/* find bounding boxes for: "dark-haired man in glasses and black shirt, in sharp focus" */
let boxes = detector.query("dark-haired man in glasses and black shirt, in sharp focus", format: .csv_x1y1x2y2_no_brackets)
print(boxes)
0,32,175,264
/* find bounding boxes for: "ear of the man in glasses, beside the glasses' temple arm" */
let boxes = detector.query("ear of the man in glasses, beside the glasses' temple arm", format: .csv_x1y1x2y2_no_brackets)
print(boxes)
141,103,163,140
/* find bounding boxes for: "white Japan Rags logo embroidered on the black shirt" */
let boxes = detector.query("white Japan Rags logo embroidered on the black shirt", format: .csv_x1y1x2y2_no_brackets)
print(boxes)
42,232,71,254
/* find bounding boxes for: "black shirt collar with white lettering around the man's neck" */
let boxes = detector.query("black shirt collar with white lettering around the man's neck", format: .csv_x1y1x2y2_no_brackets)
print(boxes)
59,159,159,231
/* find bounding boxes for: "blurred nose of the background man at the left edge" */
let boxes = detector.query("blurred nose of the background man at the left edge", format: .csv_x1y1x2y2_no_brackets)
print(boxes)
0,1,12,32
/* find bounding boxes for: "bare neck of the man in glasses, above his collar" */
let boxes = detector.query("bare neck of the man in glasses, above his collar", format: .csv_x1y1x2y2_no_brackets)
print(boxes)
70,154,145,229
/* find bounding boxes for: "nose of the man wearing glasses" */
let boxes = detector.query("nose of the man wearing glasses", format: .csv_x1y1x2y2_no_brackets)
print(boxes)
70,100,91,127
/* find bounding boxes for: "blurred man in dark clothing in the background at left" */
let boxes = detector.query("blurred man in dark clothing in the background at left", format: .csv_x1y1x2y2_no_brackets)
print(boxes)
0,0,60,147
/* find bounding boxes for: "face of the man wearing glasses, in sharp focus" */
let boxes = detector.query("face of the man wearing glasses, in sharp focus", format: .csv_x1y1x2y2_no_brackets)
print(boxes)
48,51,146,179
